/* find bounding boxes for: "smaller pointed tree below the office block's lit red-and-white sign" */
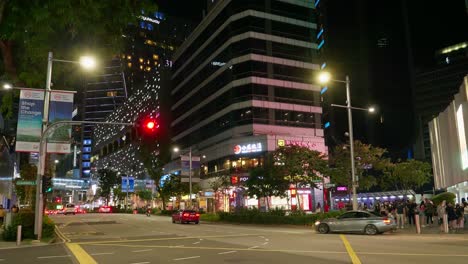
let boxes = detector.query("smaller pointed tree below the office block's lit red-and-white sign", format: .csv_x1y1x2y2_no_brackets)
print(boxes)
245,154,289,210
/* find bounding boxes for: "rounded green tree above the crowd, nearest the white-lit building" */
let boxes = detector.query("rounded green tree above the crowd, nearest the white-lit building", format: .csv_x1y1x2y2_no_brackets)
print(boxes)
382,159,432,194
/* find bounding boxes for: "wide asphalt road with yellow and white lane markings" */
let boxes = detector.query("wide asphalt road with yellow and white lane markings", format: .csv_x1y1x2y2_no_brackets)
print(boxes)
0,214,468,264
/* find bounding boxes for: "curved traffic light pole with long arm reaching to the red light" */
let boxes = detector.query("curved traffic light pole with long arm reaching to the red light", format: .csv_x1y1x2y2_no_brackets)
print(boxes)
34,120,134,240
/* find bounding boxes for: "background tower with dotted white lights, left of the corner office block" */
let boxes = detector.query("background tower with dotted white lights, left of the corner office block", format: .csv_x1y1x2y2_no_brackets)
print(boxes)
89,12,191,178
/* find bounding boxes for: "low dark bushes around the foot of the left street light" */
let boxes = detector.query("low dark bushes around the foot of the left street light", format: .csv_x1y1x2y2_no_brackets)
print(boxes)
3,209,55,241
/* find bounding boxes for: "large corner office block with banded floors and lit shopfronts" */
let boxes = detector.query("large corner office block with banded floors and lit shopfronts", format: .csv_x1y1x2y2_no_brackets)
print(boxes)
168,0,327,210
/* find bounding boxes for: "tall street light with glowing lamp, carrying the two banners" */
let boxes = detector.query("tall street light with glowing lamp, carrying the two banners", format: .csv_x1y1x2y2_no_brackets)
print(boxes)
34,52,96,240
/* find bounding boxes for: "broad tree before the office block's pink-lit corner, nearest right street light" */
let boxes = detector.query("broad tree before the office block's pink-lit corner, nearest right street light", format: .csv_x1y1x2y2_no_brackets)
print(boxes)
272,145,328,207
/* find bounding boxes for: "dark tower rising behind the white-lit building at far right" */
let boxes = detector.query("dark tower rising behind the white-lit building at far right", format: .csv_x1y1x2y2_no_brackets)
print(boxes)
414,42,468,162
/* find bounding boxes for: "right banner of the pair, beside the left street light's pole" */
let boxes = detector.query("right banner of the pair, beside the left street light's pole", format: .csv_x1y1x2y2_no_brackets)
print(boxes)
47,91,73,154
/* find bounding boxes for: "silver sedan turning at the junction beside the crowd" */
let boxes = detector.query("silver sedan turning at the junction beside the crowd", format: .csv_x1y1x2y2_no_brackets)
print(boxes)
315,211,396,235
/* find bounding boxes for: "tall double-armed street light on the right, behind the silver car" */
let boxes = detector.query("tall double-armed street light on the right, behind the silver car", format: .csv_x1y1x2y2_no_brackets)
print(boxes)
318,72,375,210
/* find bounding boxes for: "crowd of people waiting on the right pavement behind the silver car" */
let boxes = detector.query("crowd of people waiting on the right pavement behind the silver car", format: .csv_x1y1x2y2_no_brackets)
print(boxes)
358,198,468,231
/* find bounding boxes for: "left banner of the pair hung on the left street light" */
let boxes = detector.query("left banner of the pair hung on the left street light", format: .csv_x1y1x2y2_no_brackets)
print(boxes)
16,89,44,152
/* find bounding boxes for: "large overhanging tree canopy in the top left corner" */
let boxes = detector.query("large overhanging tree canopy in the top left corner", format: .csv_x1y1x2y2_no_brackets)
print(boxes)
0,0,157,117
